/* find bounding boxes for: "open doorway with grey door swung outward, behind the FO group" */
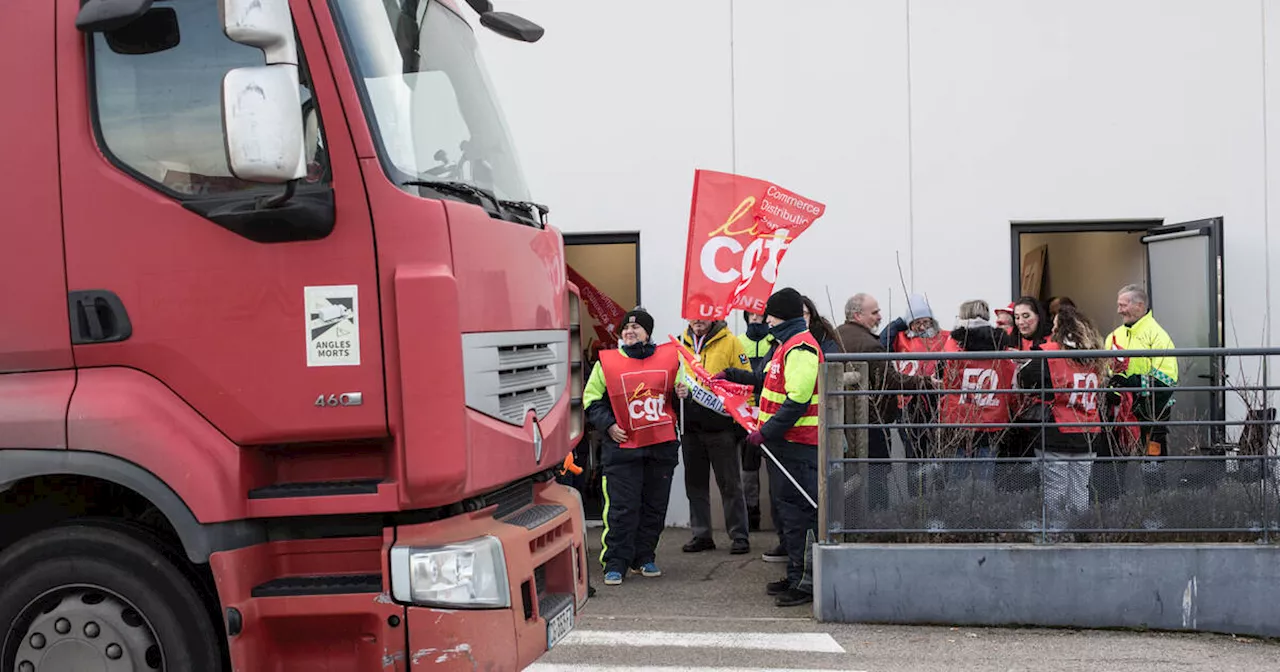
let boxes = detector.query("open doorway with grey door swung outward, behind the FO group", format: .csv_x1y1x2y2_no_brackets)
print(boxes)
1011,218,1226,454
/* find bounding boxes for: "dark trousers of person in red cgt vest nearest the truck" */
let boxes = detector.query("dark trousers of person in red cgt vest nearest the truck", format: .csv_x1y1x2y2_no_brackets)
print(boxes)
600,439,680,573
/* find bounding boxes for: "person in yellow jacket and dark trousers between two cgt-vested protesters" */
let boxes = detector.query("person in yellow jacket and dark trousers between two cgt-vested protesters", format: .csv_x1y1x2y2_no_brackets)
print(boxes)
678,320,751,554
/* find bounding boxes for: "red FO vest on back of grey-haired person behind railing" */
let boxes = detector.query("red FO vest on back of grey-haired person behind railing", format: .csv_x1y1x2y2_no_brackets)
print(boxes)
938,338,1018,431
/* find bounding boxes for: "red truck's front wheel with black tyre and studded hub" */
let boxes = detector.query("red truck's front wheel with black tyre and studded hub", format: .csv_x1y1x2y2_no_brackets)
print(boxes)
0,521,223,672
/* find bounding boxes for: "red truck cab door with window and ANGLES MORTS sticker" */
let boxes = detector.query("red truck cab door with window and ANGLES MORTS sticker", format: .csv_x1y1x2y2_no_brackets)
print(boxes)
58,0,387,445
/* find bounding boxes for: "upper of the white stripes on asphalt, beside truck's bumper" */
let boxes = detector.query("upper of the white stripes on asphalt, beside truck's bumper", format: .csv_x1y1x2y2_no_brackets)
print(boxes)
556,630,845,653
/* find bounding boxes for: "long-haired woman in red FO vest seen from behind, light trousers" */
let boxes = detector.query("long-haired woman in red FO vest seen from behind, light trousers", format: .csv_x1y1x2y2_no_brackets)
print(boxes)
1018,306,1107,527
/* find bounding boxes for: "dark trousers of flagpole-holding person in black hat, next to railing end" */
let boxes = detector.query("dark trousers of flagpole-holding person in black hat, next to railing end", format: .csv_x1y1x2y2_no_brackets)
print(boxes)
769,442,818,593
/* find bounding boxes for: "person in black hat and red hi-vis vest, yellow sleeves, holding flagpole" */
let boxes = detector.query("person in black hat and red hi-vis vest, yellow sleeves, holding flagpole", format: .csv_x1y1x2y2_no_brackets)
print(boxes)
719,287,824,607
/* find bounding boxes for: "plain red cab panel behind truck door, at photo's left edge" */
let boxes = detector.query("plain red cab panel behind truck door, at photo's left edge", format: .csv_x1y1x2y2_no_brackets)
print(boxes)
0,0,76,450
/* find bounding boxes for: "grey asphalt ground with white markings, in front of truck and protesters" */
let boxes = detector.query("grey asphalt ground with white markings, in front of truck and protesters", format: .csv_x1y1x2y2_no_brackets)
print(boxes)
531,529,1280,672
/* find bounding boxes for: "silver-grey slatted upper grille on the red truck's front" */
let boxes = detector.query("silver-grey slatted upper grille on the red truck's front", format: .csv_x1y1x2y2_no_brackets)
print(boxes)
462,330,568,426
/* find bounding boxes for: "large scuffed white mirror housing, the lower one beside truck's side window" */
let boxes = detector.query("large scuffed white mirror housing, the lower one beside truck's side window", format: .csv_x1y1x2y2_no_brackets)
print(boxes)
223,64,307,184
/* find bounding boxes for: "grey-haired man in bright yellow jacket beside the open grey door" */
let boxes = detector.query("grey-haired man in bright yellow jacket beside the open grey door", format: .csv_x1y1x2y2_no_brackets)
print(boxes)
1107,284,1178,456
